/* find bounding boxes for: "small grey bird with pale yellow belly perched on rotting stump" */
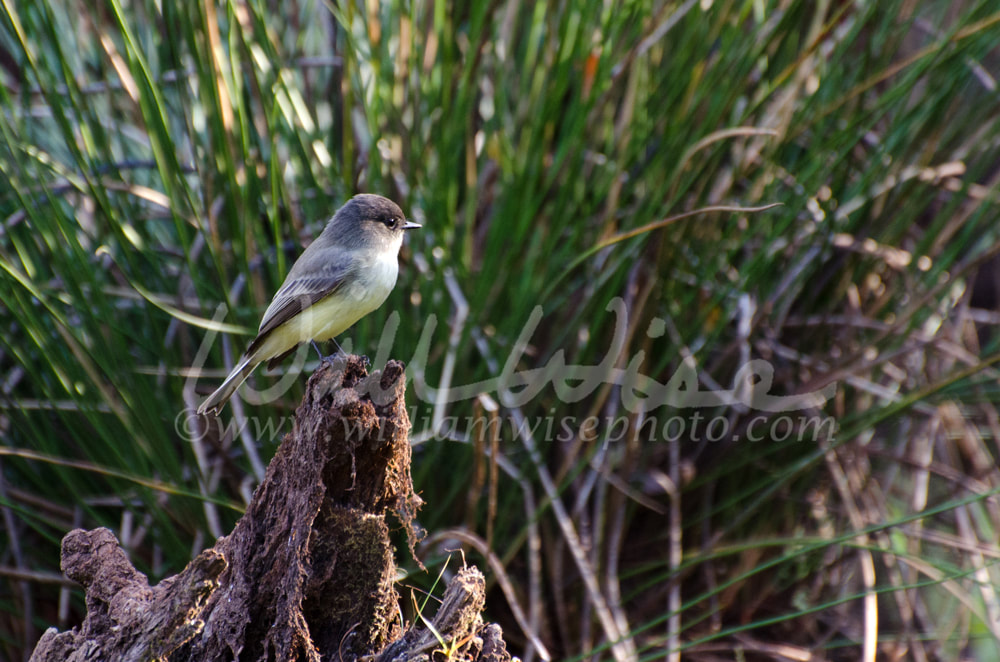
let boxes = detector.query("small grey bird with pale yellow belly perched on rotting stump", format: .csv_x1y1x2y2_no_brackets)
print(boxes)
198,194,420,414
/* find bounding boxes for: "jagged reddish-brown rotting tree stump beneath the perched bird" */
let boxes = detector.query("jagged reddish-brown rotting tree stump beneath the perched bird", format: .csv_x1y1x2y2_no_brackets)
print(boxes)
31,357,511,662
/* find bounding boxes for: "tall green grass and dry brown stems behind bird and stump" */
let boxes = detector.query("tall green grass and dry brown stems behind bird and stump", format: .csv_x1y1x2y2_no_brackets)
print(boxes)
0,0,1000,660
